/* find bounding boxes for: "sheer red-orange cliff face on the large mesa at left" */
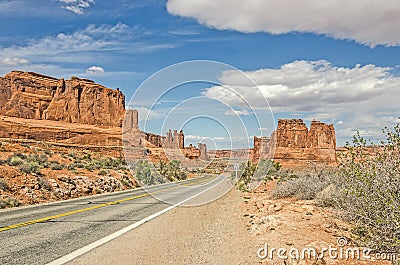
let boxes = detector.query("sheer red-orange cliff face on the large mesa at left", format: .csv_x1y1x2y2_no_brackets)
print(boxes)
0,71,125,127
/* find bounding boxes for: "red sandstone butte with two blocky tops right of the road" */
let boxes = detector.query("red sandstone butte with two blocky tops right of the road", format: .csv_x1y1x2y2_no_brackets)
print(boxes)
253,119,337,166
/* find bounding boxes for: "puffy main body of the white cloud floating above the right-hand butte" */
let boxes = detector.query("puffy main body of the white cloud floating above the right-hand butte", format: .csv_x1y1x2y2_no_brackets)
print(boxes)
203,60,400,111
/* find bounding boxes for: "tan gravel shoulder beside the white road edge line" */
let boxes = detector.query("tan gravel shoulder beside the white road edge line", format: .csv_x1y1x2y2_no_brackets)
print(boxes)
70,190,259,265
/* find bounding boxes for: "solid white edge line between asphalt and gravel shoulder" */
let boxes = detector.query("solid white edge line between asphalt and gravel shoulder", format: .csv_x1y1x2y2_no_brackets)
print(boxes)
46,175,225,265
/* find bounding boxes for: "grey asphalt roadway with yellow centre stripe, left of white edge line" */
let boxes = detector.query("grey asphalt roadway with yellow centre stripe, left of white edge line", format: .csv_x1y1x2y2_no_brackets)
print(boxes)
0,176,224,265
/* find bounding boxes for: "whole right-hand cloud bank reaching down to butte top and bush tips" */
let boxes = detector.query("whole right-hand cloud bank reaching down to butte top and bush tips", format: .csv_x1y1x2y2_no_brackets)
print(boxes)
203,60,400,143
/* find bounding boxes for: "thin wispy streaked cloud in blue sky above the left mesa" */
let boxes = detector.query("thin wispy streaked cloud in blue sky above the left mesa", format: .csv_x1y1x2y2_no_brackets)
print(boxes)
0,23,176,72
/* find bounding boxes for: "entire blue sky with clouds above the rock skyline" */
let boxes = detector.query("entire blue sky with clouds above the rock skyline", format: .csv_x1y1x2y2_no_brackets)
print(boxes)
0,0,400,149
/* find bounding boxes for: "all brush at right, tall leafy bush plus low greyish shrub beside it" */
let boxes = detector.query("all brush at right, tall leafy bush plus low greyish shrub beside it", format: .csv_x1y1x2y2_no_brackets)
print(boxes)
262,124,400,253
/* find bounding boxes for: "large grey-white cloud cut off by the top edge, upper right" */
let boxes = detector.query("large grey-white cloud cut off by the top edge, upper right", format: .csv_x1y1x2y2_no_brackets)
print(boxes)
167,0,400,46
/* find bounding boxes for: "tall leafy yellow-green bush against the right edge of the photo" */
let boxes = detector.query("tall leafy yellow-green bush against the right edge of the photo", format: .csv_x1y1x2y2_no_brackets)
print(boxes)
340,124,400,252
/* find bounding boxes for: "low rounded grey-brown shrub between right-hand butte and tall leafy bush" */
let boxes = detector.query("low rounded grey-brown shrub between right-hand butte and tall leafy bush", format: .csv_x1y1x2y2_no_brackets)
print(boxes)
272,167,338,200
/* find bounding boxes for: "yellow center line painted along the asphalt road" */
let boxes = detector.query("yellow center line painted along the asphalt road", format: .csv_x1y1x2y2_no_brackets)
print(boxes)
0,177,216,232
